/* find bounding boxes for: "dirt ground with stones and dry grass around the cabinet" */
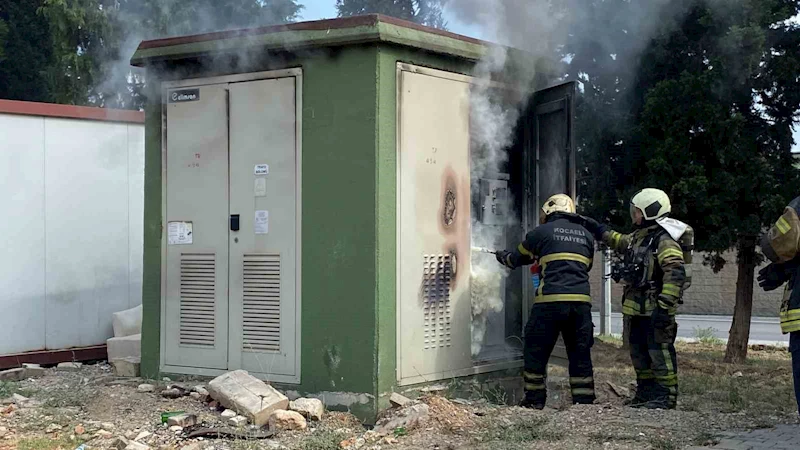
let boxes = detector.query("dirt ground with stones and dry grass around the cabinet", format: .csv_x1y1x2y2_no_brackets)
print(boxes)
0,341,797,450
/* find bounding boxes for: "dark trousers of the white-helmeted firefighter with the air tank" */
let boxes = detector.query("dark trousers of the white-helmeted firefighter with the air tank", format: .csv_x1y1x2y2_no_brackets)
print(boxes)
624,315,678,408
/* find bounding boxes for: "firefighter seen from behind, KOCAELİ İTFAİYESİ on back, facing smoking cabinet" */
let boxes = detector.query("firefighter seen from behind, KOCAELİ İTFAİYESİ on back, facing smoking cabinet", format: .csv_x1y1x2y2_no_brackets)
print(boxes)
496,194,595,409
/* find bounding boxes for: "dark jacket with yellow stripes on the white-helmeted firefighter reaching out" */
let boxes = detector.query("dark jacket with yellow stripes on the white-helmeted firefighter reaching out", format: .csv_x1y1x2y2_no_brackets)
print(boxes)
602,224,686,316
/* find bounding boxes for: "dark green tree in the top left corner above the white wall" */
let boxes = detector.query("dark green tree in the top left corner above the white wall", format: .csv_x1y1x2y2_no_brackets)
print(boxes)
0,0,53,102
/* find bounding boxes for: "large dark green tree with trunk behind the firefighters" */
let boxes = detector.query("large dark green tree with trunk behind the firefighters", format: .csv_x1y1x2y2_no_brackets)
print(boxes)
567,0,800,360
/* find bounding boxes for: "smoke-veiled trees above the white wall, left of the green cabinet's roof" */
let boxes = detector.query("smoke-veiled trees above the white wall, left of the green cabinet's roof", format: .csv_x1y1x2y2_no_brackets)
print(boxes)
5,0,302,109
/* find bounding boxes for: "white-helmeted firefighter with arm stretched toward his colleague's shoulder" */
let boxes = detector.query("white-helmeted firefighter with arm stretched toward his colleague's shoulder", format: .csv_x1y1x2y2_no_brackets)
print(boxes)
585,189,686,409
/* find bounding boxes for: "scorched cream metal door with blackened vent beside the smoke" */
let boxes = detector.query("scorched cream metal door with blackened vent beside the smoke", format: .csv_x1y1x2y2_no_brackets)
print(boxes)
397,71,472,384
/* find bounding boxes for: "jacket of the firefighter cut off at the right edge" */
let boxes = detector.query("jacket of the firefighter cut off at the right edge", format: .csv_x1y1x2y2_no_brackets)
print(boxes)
761,197,800,334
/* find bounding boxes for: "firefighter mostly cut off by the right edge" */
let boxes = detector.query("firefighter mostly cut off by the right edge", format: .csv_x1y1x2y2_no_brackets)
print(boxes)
758,197,800,413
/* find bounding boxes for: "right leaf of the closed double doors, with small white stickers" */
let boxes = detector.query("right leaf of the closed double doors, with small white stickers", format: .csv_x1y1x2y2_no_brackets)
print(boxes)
229,77,299,377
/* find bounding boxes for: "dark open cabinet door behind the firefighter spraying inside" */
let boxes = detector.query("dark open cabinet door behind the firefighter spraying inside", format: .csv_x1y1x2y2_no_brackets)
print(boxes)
523,81,577,358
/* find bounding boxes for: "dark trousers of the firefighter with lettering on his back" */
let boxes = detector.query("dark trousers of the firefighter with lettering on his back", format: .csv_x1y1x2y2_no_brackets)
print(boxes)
523,302,595,406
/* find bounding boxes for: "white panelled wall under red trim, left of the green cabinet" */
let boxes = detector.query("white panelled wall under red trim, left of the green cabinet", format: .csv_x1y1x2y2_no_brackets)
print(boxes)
0,114,144,355
